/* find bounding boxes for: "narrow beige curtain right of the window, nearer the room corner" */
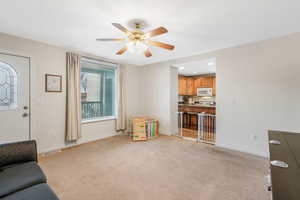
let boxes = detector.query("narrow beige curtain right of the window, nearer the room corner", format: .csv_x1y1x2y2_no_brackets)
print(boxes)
116,65,126,132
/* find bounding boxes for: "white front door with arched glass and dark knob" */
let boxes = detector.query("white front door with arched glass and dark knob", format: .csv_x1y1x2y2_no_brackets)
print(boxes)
0,53,30,144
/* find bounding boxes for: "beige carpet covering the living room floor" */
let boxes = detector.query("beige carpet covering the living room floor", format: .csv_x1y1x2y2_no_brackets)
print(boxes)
40,136,270,200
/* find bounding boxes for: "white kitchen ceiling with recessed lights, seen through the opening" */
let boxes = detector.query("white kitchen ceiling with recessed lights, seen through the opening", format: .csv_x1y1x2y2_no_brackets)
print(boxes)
173,58,216,76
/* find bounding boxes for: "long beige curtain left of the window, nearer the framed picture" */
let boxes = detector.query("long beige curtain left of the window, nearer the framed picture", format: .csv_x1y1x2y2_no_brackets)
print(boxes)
66,52,81,142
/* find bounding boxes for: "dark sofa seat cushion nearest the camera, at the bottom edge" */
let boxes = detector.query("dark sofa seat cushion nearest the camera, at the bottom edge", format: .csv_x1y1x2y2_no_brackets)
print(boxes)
1,183,58,200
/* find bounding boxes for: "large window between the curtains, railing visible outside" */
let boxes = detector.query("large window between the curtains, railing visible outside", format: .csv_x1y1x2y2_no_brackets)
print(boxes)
80,58,117,121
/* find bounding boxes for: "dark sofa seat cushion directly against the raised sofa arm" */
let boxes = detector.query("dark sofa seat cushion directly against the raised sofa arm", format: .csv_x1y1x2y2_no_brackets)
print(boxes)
0,162,46,197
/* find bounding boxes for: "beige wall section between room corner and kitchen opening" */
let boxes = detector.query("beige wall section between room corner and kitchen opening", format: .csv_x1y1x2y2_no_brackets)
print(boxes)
136,63,178,135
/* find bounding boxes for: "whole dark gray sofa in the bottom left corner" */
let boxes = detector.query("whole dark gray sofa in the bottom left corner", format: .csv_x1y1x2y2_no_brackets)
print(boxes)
0,140,58,200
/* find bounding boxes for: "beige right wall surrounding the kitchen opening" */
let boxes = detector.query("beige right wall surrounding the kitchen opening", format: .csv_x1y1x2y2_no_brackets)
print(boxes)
141,33,300,156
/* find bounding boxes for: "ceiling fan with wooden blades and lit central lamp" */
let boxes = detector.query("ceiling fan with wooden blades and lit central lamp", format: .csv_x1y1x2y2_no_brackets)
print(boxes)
96,23,175,57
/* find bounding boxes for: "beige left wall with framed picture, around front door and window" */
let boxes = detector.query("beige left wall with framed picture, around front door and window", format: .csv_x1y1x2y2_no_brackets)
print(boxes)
0,33,132,152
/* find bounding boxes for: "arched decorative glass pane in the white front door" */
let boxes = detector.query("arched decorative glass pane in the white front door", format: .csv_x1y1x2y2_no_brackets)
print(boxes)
0,61,17,110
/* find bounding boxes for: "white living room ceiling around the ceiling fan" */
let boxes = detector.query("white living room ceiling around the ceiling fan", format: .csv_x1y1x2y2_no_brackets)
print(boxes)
0,0,300,65
